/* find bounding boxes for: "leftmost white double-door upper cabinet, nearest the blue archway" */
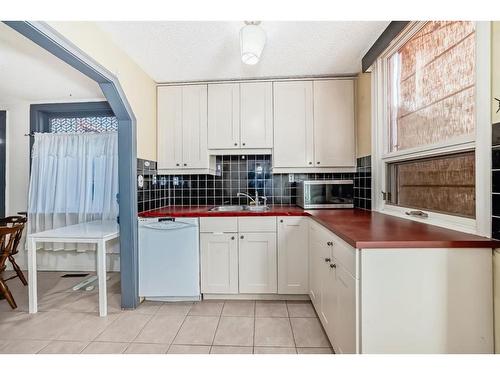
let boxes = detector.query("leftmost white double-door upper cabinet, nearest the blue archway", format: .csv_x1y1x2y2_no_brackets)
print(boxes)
158,85,209,171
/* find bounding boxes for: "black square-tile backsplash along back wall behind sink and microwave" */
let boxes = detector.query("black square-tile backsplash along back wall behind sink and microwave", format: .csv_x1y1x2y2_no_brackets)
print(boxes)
137,155,371,212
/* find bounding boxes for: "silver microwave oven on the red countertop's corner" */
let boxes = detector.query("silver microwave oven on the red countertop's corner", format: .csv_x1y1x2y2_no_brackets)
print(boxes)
297,180,354,209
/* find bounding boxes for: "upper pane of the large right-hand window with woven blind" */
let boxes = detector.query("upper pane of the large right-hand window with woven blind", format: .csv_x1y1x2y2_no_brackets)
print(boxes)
389,21,475,151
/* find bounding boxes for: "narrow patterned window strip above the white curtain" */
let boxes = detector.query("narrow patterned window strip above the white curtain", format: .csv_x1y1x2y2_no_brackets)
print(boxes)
49,116,118,133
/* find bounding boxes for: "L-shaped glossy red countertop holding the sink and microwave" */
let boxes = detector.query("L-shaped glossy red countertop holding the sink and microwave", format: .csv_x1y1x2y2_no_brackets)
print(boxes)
139,205,500,249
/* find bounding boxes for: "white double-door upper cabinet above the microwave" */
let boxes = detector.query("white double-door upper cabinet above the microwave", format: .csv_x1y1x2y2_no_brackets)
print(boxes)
273,79,356,173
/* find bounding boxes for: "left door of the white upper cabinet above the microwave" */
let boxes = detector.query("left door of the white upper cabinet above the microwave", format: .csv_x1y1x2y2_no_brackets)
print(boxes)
273,81,314,168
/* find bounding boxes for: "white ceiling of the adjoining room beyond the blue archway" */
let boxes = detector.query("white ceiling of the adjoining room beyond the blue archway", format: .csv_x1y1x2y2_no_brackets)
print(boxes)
0,22,104,103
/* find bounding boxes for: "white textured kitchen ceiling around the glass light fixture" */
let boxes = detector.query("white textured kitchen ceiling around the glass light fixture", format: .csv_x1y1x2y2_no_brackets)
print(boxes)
97,21,389,82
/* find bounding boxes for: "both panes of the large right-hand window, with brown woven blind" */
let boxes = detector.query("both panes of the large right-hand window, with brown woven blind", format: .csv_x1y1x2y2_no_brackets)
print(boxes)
385,21,476,218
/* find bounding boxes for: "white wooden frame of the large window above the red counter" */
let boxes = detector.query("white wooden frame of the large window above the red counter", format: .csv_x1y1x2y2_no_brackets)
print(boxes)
372,22,491,237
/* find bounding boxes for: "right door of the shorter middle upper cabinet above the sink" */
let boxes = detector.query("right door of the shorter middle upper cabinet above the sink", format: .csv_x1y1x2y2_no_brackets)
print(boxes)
240,82,273,148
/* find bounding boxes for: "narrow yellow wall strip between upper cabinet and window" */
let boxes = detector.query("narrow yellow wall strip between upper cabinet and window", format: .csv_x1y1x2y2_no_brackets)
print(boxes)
356,73,372,158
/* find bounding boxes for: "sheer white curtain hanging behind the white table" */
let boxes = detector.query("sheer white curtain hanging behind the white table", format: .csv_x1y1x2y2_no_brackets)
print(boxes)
28,132,118,252
